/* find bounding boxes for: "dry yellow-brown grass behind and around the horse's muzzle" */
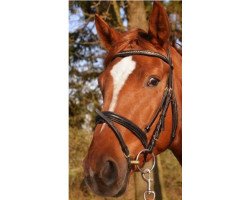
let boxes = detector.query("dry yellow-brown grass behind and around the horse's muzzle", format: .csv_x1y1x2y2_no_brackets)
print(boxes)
69,128,182,200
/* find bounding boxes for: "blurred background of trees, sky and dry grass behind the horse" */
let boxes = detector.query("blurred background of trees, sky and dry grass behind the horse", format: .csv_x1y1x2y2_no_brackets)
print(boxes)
69,1,182,200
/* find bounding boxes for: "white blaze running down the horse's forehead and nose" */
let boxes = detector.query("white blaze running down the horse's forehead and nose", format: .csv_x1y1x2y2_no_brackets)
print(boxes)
100,56,136,132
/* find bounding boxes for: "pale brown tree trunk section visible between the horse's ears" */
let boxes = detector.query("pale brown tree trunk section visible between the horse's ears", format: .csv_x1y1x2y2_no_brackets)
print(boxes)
128,1,148,31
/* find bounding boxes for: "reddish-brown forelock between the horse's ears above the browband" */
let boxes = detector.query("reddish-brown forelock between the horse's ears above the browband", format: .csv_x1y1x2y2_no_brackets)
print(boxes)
104,28,166,66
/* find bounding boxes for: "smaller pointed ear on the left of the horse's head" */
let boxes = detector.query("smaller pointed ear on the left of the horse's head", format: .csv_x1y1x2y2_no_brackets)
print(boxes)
95,14,119,50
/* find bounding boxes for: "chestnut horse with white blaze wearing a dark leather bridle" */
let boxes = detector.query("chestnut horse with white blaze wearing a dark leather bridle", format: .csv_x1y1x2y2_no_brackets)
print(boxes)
84,2,182,196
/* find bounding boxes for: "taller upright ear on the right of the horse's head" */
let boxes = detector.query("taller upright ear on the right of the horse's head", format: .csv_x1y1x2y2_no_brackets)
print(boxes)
148,1,171,49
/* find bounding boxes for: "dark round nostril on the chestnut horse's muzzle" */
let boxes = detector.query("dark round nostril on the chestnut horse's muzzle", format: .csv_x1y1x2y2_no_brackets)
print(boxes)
100,160,118,186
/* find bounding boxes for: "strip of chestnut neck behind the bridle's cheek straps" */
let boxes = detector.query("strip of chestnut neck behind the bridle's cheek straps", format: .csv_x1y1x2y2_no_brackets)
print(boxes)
170,46,182,164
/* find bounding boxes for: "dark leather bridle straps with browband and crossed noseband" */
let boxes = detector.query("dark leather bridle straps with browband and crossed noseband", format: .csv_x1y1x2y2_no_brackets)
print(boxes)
96,50,178,169
